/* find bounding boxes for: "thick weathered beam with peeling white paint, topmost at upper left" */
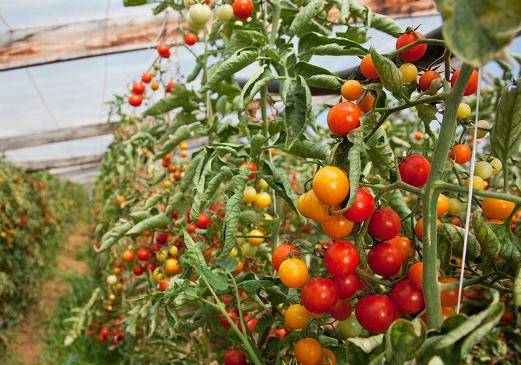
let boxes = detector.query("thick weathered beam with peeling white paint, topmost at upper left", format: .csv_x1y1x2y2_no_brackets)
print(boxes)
0,15,182,71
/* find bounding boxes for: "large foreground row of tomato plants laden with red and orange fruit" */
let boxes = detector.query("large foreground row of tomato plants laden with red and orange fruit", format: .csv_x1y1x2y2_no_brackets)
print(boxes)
67,0,521,365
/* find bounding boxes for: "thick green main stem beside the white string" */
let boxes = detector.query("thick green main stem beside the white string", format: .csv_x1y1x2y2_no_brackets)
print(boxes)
422,64,472,328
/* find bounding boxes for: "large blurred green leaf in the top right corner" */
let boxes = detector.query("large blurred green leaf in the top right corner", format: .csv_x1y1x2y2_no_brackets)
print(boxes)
435,0,521,67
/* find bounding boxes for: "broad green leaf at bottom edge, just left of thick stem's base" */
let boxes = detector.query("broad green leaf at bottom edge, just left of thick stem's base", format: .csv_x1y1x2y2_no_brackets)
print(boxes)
385,319,427,364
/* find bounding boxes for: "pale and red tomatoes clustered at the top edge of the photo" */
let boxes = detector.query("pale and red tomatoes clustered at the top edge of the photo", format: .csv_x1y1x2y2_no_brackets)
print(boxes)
184,0,254,46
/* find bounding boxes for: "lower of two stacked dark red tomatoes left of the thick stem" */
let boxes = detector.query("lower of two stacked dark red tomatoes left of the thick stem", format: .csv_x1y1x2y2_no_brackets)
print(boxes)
367,242,403,277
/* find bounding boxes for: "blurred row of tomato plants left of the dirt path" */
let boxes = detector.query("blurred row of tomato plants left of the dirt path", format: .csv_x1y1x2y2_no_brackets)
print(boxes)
0,160,87,347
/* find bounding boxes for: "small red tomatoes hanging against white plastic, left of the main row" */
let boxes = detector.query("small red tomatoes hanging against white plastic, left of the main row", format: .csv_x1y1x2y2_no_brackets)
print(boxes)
128,44,175,107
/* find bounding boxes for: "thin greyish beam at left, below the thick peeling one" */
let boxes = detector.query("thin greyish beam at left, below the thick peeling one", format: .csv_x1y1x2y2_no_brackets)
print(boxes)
0,123,116,152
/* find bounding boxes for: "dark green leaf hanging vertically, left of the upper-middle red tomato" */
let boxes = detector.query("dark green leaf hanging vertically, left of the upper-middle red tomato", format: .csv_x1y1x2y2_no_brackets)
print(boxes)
284,76,311,146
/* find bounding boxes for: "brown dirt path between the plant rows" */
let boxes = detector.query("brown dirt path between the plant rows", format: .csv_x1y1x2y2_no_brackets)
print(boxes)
7,223,91,365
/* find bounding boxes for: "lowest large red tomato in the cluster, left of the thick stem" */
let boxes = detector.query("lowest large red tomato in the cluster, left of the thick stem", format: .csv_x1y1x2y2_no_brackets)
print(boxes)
355,295,398,333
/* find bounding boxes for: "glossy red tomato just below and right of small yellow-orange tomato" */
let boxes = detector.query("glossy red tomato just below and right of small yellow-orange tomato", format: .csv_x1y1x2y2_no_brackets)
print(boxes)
298,276,338,314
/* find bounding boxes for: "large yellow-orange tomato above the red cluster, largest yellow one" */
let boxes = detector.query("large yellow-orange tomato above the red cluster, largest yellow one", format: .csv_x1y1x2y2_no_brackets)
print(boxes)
312,166,349,206
